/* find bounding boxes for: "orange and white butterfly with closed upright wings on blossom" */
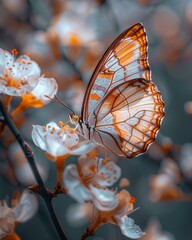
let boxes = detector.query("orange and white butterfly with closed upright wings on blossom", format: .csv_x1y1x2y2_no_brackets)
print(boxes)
70,23,164,158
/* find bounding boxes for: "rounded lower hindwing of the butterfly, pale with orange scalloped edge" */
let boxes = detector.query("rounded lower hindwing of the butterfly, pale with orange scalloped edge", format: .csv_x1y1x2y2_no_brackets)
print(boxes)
88,79,164,158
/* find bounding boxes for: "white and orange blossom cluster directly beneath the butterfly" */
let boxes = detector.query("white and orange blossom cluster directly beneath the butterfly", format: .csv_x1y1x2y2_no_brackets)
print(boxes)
32,122,144,239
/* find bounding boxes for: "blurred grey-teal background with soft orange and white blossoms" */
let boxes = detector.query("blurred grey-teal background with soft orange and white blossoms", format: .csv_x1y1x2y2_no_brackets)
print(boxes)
0,0,192,240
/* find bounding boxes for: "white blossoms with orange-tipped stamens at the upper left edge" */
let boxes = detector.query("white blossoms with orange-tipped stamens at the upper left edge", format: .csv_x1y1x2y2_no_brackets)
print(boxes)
0,49,58,103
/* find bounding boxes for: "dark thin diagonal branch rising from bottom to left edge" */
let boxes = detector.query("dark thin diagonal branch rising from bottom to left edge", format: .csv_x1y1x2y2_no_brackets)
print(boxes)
0,98,67,240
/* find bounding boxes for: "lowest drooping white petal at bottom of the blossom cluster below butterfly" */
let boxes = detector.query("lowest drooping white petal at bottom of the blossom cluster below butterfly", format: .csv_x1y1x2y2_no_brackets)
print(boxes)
115,216,145,239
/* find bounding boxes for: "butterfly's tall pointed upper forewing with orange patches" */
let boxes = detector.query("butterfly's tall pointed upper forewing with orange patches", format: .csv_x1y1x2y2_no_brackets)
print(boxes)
81,23,151,121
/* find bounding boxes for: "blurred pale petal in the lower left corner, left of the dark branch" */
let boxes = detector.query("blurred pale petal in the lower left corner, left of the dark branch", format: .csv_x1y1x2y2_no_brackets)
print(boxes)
13,191,38,222
